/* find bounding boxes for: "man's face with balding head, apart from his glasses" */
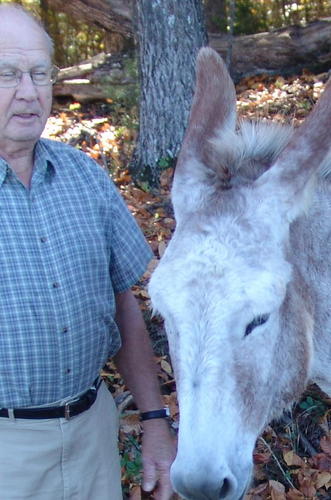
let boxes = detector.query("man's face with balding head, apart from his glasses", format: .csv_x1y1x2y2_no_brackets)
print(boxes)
0,10,52,156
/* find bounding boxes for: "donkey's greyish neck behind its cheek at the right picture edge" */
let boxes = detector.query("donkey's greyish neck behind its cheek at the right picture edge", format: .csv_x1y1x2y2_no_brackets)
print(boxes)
288,179,331,393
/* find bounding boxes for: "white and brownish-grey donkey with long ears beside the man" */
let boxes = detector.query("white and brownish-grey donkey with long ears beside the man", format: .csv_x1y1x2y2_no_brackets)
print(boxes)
149,48,331,500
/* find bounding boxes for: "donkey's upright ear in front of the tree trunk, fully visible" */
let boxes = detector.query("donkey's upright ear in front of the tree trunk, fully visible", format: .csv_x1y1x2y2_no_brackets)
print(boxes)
172,47,236,221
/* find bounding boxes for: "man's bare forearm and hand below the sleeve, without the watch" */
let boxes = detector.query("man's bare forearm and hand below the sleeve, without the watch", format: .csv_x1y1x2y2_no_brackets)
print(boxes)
115,290,176,500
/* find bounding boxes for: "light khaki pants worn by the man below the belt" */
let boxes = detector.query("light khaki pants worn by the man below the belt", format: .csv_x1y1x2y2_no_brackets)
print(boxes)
0,383,122,500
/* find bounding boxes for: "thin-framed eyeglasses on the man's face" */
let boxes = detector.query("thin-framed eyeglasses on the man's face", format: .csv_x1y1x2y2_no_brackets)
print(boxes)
0,66,60,88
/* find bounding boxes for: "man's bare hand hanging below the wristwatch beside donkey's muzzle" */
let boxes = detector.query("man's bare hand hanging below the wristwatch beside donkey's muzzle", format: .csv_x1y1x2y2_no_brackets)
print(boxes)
142,419,176,500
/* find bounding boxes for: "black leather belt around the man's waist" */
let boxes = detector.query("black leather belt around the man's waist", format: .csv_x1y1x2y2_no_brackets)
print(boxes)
0,378,101,420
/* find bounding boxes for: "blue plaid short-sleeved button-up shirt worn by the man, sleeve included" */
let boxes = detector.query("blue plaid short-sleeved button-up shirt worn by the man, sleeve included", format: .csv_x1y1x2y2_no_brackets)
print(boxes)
0,139,151,408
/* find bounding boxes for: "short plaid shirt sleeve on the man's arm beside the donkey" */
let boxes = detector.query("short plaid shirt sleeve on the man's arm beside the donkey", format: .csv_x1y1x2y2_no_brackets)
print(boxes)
110,187,153,293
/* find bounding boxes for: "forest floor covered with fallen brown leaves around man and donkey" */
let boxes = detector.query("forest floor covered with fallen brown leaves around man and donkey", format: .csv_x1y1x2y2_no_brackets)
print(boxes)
44,74,331,500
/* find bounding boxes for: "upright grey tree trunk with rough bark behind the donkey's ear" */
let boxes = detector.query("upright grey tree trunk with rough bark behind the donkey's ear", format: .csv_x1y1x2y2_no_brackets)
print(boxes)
131,0,207,184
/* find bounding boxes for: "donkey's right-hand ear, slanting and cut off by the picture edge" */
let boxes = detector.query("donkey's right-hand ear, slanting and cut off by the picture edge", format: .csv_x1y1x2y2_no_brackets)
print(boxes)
255,79,331,221
